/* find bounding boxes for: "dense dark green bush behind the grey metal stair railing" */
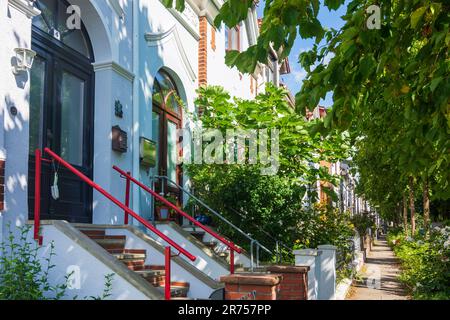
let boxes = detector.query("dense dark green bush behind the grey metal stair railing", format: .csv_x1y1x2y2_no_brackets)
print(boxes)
188,165,304,258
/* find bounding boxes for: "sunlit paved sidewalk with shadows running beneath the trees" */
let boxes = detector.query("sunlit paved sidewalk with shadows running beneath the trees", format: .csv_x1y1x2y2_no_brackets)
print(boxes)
346,239,408,300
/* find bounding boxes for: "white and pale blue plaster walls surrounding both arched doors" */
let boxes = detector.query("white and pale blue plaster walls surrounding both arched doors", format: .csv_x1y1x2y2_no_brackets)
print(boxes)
0,0,266,241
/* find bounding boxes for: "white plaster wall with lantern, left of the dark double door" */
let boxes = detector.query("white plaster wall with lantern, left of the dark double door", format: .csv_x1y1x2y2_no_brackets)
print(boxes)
0,1,35,238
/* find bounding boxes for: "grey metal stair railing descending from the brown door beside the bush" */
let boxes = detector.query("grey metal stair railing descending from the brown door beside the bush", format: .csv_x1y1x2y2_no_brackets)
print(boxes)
152,175,273,271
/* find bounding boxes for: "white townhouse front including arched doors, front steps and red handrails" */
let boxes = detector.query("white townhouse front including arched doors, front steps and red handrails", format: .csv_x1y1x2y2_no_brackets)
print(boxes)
0,0,298,299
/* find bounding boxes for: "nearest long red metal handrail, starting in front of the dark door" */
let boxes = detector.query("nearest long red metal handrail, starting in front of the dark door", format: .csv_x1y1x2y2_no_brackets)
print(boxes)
34,148,196,261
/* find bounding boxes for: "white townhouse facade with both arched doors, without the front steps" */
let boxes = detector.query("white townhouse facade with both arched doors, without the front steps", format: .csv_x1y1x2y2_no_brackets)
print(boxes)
0,0,282,232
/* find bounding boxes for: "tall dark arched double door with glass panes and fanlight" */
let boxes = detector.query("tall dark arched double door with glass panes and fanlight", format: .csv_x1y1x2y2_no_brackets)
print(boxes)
28,0,94,223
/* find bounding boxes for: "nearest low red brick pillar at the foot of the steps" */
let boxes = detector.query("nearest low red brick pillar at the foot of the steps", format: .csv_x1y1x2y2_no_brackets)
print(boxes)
220,274,281,300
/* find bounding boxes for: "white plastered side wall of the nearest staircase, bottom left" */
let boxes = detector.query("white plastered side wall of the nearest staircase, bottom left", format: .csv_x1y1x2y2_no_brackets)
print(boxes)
34,225,148,300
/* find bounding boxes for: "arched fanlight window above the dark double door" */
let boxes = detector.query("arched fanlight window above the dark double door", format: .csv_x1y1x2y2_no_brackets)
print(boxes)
33,0,92,59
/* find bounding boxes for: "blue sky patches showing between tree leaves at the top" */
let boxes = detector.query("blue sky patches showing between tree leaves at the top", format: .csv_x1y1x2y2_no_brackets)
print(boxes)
257,1,346,107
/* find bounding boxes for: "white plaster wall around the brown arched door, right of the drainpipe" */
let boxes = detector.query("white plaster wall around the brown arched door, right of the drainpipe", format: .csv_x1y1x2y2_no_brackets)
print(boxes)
135,0,198,219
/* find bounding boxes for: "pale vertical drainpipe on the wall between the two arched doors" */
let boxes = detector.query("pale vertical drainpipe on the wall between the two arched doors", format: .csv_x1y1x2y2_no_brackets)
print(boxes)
131,0,140,220
